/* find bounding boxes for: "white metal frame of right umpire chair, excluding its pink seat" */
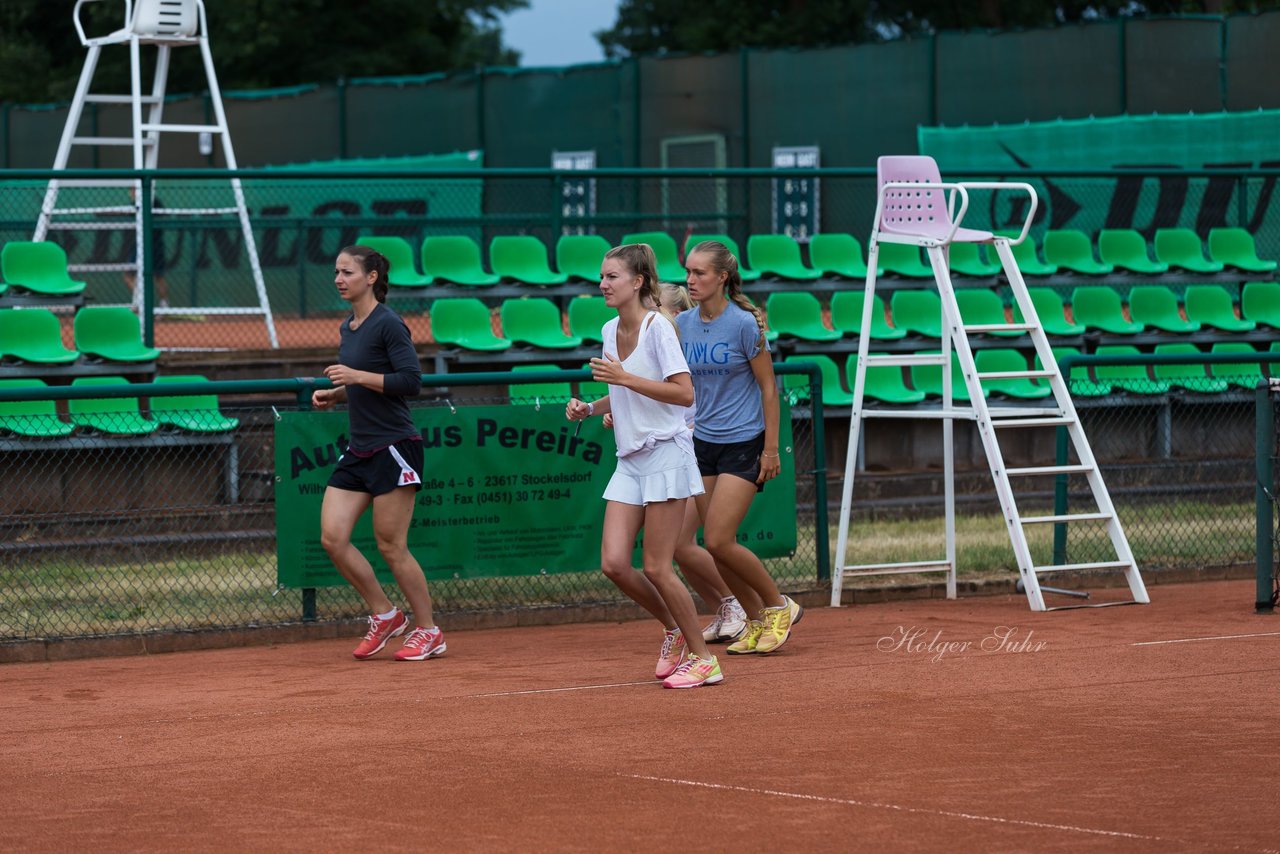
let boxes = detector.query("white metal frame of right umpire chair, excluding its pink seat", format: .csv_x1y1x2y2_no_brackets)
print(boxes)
831,170,1149,611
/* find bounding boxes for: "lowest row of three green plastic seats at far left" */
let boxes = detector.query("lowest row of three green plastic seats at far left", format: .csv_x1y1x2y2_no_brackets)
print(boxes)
0,375,239,438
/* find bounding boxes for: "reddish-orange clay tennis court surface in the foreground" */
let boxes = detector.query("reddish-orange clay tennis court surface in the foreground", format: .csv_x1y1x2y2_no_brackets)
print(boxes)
0,581,1280,853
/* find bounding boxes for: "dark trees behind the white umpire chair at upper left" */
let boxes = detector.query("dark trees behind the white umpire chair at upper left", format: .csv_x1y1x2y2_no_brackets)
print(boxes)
0,0,529,104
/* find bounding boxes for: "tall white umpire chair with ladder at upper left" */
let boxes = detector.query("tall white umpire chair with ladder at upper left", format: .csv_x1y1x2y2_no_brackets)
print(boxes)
32,0,279,347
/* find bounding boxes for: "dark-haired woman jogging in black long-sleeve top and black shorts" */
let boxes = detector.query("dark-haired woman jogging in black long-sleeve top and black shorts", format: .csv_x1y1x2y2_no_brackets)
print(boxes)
311,246,444,661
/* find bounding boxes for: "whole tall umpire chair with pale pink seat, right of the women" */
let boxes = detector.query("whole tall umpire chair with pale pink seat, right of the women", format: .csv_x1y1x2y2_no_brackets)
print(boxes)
831,156,1149,611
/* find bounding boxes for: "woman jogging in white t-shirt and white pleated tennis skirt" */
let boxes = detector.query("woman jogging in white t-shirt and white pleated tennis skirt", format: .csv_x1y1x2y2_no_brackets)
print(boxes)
564,243,723,688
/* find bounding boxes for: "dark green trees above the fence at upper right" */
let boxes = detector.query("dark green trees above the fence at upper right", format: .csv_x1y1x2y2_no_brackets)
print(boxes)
595,0,1280,58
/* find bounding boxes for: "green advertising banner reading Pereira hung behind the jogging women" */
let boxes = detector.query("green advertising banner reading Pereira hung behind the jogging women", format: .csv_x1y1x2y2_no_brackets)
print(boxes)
275,403,796,588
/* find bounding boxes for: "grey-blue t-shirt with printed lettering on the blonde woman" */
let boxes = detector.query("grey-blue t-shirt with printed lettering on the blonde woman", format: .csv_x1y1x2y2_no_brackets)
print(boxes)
676,302,768,444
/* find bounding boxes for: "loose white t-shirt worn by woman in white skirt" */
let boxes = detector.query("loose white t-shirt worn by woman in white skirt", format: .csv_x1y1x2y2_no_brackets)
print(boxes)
600,311,694,457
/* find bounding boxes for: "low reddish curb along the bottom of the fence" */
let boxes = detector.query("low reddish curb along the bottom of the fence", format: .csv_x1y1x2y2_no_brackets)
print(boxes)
0,563,1256,665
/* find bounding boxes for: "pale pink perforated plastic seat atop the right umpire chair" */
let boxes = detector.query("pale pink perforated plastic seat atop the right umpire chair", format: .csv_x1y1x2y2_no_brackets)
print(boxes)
876,155,993,243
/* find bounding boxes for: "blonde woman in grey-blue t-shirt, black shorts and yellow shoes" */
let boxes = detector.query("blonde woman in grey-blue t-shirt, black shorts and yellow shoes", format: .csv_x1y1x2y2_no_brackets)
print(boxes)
676,241,804,656
